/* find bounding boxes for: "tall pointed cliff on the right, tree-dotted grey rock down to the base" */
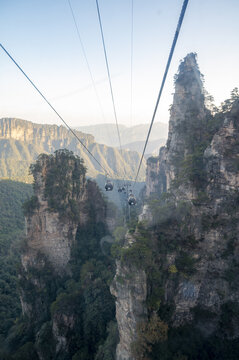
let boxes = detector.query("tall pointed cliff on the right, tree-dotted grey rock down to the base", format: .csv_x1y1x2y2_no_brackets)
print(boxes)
113,54,239,360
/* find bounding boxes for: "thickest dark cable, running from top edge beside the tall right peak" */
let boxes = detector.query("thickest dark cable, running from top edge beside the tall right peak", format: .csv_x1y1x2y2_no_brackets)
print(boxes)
134,0,189,186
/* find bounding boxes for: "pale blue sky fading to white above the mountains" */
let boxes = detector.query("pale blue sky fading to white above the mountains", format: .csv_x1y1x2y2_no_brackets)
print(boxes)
0,0,239,127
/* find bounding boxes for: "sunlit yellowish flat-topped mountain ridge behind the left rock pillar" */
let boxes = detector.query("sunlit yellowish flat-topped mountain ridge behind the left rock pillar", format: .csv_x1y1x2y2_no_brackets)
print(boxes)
0,118,145,182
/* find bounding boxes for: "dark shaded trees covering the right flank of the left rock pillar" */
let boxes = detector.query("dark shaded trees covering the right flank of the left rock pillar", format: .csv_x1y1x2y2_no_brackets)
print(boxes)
41,216,118,360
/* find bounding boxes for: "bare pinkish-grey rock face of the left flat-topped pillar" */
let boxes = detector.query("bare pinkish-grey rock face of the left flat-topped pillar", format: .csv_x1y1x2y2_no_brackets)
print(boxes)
22,152,88,272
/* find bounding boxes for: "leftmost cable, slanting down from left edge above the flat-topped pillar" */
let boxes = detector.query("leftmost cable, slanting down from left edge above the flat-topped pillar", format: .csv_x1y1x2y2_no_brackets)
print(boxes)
0,44,112,176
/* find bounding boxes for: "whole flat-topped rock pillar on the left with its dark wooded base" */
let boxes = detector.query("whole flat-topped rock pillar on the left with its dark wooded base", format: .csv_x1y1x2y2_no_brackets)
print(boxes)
6,150,117,360
